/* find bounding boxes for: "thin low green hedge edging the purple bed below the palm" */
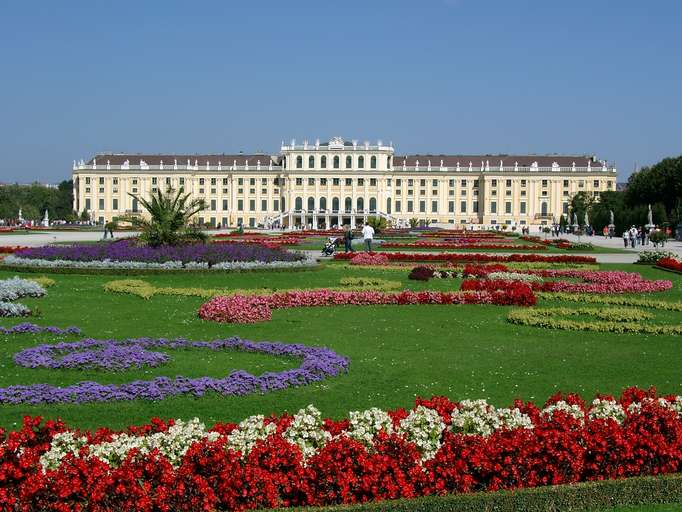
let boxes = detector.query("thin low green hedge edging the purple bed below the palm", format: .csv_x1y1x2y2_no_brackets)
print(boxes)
0,262,325,276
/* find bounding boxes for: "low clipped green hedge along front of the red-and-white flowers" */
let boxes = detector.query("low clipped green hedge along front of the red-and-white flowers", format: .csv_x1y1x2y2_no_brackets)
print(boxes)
270,473,682,512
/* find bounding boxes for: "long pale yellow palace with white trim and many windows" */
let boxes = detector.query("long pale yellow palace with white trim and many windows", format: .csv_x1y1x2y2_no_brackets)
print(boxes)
73,137,616,228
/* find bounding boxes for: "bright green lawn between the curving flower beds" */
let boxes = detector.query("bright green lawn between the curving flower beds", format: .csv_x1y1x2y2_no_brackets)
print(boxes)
0,265,682,427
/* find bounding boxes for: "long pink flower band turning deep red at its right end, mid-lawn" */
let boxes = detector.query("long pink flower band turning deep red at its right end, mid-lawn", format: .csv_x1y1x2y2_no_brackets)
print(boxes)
194,283,536,323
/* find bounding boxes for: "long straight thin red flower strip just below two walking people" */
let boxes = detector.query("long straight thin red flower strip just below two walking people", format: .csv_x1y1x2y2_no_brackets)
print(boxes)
334,252,597,263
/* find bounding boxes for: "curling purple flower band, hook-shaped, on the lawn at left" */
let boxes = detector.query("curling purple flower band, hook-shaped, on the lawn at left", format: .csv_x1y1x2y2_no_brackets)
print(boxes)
0,337,349,404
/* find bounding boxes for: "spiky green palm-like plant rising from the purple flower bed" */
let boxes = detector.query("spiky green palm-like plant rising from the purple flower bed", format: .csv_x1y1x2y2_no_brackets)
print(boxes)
124,189,207,247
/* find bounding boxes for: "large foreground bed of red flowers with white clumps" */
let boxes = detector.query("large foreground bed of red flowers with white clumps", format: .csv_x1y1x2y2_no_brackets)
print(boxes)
0,388,682,511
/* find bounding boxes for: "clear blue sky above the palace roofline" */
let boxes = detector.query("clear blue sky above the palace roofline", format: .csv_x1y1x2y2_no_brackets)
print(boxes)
0,0,682,182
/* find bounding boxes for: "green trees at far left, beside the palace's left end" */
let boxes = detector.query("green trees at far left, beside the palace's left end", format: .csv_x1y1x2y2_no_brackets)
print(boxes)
0,180,76,221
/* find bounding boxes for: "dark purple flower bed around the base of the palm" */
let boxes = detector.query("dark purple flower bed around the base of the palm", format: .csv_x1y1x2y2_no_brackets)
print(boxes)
15,239,302,265
